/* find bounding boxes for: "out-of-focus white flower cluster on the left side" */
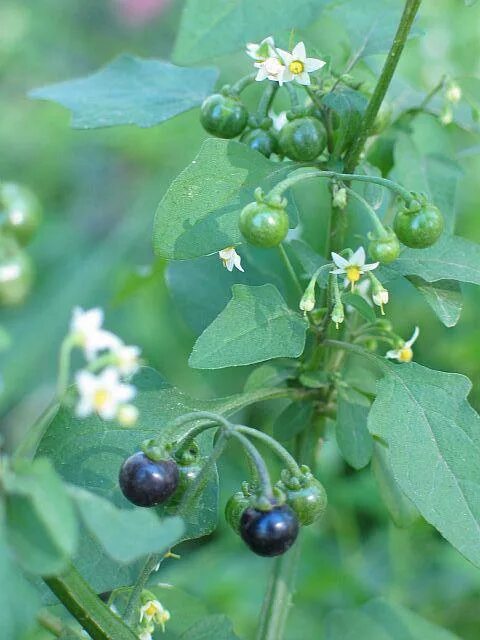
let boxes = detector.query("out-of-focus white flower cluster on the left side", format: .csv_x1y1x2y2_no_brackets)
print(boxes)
66,307,140,426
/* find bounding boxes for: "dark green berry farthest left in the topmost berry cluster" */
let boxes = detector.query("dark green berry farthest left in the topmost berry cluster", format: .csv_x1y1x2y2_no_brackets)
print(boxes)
200,93,248,139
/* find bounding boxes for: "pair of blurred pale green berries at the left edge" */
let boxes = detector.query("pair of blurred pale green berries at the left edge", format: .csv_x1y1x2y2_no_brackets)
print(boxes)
0,182,41,306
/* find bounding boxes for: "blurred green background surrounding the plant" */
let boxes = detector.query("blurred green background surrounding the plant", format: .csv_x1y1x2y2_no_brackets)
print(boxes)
0,0,480,640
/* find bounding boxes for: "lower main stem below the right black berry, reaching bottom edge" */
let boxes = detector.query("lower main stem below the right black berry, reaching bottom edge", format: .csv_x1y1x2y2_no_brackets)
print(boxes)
255,540,300,640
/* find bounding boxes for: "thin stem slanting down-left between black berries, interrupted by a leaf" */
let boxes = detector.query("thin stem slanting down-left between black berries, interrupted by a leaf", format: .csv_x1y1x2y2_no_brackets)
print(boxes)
124,429,231,624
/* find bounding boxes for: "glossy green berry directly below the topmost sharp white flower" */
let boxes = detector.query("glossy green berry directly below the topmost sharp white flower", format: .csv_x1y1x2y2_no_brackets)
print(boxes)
279,116,326,162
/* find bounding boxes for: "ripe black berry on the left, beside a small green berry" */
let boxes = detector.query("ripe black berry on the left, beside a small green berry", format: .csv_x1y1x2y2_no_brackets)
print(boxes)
118,451,179,507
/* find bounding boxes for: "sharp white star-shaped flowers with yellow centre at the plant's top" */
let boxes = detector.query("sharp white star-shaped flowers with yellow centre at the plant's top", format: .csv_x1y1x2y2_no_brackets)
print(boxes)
246,36,326,86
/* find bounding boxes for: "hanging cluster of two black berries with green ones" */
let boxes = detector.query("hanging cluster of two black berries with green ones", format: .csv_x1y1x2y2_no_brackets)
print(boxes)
119,414,327,557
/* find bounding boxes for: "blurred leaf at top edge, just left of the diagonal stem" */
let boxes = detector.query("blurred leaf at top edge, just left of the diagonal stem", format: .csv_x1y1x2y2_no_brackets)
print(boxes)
333,0,418,59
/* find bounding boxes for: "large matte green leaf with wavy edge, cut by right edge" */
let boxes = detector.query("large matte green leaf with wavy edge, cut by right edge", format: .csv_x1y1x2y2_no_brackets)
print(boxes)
368,361,480,566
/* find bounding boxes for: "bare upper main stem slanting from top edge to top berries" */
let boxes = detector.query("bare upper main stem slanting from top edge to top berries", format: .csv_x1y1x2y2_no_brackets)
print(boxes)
345,0,421,173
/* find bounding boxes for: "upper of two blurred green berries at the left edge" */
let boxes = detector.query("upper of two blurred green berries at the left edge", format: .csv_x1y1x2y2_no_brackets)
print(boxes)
0,182,41,246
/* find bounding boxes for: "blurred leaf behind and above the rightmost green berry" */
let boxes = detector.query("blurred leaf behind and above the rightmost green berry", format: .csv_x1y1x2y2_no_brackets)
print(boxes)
394,134,462,233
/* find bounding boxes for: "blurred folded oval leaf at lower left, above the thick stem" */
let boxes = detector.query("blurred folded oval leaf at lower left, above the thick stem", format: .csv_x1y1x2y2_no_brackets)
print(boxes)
5,460,78,575
